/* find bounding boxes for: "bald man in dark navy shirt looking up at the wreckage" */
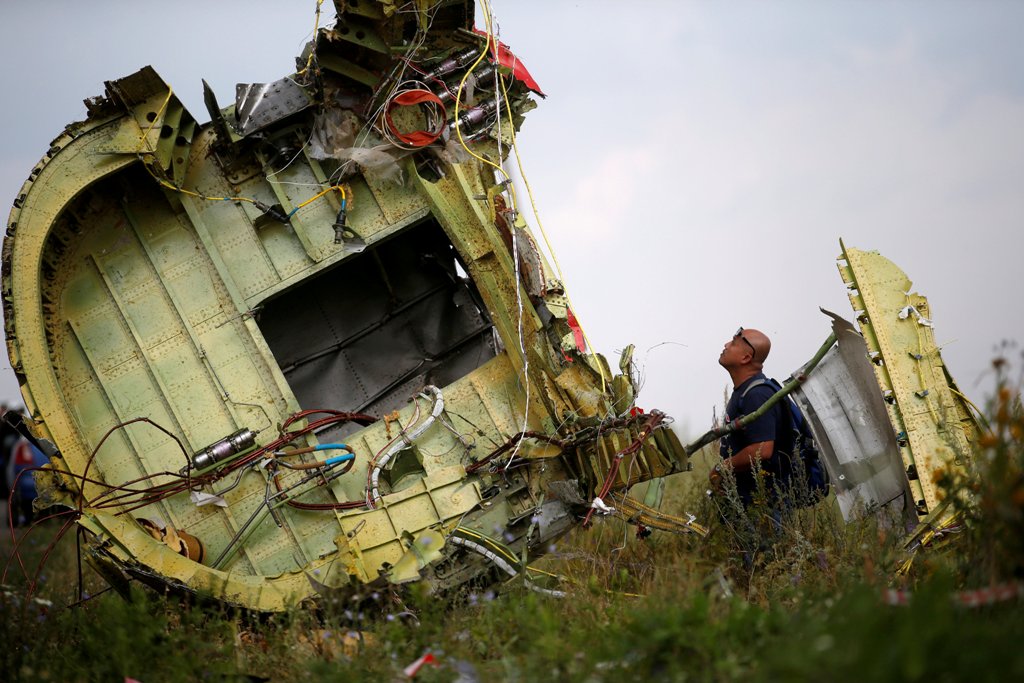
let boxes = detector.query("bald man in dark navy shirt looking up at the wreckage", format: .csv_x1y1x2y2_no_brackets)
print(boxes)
710,328,794,505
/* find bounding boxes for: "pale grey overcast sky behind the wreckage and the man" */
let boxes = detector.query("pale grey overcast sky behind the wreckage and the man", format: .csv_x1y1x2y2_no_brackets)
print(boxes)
0,0,1024,433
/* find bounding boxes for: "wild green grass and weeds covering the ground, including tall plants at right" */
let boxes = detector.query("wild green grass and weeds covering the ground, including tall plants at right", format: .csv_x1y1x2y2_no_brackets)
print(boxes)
6,362,1024,683
